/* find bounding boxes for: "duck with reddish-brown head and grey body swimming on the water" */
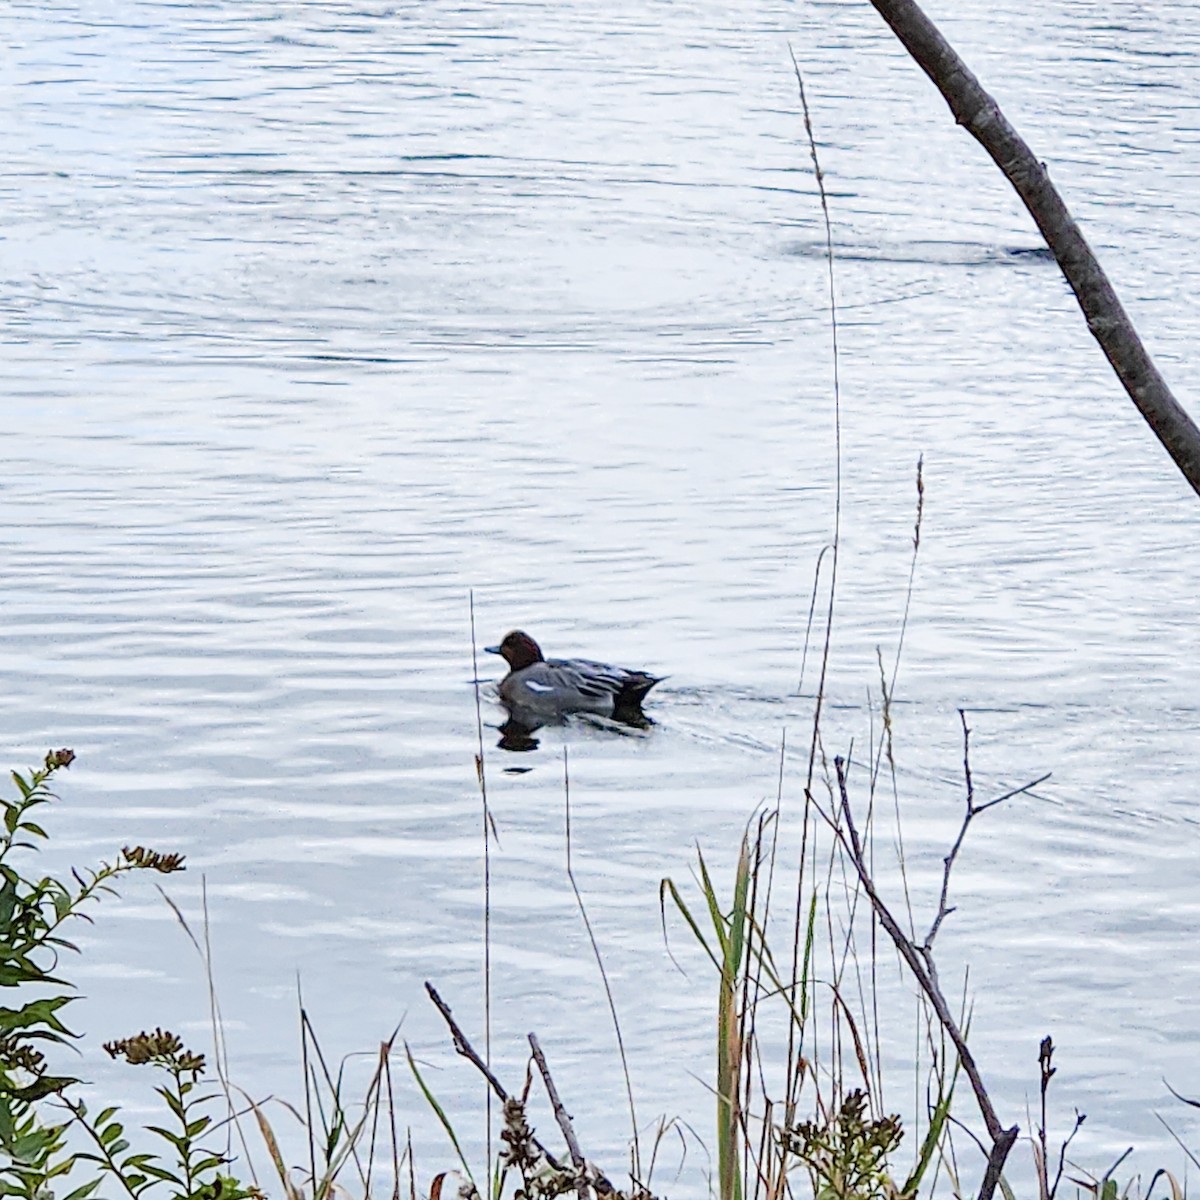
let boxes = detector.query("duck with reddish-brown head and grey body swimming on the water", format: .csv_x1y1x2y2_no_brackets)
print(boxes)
485,629,664,720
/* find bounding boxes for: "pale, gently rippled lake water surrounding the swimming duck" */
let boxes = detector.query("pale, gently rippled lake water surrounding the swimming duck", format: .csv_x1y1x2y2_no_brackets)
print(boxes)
0,0,1200,1194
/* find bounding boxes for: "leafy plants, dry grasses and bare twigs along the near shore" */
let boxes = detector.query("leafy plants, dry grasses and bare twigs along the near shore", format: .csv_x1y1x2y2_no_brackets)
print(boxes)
0,739,1195,1200
